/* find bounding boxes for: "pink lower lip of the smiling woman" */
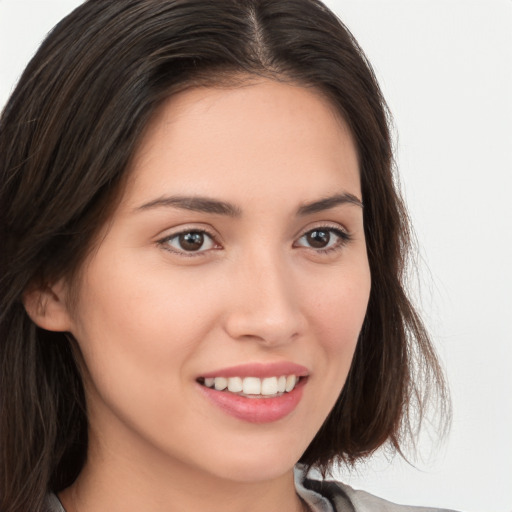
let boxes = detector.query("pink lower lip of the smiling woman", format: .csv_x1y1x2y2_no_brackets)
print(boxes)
198,378,307,423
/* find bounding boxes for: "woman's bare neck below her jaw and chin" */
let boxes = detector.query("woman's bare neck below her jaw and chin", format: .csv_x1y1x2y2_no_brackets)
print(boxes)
60,440,309,512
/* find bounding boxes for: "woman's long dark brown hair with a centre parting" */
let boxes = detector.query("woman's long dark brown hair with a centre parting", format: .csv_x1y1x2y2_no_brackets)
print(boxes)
0,0,448,512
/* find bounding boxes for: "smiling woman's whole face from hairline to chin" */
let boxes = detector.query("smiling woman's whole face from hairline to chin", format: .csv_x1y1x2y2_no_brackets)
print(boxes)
64,80,370,482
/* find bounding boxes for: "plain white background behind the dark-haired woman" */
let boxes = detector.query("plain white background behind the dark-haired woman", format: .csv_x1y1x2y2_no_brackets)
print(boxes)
0,0,512,512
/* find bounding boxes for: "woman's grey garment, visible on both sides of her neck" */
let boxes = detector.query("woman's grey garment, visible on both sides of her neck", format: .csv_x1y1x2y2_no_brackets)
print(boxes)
44,466,455,512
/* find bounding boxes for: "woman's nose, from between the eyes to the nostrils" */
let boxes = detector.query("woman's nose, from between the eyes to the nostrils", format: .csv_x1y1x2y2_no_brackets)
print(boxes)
225,251,306,347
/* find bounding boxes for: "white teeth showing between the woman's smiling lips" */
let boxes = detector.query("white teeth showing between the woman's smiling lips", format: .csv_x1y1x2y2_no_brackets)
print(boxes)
197,375,305,398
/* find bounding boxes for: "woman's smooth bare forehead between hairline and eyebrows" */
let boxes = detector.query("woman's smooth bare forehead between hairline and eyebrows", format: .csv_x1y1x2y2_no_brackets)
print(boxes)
121,80,360,210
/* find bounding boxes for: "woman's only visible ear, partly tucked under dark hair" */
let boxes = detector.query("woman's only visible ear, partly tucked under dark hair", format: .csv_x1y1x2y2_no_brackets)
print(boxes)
23,279,72,332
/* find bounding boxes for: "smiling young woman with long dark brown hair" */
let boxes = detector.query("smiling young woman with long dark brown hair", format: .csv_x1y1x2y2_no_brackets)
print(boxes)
0,0,446,512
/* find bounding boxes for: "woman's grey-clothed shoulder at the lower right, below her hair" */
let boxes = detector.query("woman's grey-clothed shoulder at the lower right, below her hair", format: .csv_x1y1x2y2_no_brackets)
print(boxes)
304,479,454,512
